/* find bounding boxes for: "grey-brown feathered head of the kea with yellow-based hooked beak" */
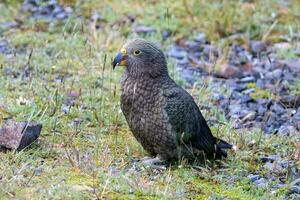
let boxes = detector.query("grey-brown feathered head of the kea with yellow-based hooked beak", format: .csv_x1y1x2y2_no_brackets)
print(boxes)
112,39,168,78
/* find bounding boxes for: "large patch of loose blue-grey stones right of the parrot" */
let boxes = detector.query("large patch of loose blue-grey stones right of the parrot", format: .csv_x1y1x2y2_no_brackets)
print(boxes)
168,33,300,135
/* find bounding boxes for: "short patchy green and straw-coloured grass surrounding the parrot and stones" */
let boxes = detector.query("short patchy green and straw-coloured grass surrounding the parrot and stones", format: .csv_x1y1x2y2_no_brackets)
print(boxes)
0,0,300,199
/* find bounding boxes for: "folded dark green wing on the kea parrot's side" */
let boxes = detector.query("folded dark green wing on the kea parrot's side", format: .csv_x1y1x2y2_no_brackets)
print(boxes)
164,85,217,154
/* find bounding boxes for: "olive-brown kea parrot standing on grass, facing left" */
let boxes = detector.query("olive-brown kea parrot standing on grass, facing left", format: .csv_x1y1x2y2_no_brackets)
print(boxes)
112,38,233,162
